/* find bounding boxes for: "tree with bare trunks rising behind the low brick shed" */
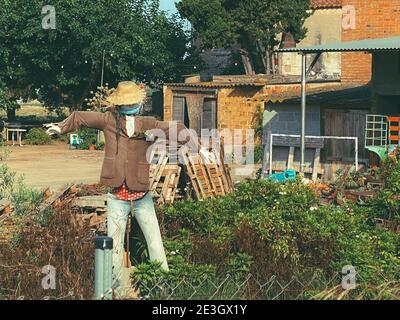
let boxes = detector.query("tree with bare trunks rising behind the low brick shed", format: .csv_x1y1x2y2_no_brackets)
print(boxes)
176,0,310,74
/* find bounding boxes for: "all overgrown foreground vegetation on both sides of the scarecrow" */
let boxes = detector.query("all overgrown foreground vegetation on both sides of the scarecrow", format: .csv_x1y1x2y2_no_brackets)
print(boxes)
0,148,400,299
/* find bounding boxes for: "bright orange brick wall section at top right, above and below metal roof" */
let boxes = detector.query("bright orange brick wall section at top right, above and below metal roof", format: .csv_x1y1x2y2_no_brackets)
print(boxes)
342,0,400,83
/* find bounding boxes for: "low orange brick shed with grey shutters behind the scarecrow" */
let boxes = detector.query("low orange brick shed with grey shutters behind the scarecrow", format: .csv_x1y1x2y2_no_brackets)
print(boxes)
164,76,340,142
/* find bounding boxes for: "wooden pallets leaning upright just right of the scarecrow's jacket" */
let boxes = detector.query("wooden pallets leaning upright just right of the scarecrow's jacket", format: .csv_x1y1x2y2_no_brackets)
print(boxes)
150,147,233,204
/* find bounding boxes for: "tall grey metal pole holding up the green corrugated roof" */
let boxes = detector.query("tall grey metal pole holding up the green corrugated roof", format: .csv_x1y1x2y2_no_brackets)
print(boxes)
300,53,307,173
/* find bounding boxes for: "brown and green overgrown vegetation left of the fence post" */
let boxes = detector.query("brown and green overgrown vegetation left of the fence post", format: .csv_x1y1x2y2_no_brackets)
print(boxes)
0,149,94,300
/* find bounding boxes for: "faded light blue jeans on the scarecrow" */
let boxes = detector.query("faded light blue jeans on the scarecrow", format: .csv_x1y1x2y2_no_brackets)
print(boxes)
107,193,168,286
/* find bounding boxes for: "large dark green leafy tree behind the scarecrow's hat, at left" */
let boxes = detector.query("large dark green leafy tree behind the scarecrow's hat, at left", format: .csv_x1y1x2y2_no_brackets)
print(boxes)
0,0,195,117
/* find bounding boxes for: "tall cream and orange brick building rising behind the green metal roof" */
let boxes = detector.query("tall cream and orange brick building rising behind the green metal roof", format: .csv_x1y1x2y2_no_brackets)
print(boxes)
280,0,400,84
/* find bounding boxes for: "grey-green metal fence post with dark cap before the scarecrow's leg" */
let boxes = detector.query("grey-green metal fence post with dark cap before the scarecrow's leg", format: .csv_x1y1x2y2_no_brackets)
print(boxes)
94,237,113,300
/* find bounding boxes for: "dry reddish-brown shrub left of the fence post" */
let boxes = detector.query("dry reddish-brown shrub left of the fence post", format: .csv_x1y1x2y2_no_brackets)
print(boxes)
0,206,94,300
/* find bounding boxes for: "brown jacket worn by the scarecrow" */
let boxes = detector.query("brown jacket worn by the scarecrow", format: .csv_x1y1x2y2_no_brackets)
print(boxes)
58,108,194,191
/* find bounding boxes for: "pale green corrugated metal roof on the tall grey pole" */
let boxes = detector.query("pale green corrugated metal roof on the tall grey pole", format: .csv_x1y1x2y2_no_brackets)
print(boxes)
276,37,400,53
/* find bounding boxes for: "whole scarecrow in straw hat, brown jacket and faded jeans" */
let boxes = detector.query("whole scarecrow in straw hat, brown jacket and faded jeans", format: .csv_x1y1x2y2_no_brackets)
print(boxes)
47,81,206,296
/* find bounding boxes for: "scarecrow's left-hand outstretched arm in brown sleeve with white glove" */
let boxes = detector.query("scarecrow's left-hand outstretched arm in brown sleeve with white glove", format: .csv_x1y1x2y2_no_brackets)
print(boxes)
47,111,107,134
